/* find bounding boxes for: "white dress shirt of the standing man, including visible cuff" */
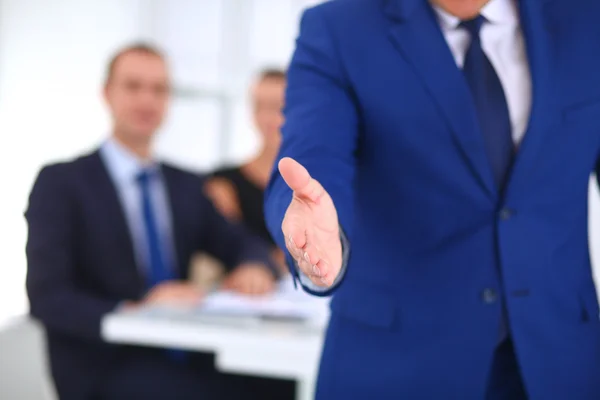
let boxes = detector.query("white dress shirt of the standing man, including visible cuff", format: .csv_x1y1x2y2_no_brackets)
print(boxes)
299,0,532,292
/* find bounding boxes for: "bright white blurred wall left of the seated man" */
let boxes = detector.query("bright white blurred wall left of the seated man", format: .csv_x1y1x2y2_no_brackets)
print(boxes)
0,0,152,321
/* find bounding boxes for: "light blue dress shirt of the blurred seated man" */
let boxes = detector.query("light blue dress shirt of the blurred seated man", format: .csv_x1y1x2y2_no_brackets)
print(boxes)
100,137,177,274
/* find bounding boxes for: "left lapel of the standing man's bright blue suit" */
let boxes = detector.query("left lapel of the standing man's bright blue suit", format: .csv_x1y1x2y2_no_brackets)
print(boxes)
385,0,497,196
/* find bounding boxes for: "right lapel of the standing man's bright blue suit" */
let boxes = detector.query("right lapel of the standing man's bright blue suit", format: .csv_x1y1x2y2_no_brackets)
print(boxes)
506,0,560,196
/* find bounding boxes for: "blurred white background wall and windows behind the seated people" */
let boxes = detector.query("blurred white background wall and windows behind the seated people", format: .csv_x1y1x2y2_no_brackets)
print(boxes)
0,0,320,324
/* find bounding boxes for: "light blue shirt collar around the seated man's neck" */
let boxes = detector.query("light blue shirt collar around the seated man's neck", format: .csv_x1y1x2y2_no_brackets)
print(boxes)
100,137,159,183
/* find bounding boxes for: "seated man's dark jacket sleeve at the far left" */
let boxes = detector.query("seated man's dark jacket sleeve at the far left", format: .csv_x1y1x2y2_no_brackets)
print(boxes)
25,166,117,340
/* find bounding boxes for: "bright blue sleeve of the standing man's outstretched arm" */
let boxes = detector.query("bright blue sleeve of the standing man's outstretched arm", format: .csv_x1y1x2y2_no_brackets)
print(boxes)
265,6,358,295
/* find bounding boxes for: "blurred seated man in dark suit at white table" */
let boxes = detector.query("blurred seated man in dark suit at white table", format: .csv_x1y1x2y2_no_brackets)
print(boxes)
26,45,276,400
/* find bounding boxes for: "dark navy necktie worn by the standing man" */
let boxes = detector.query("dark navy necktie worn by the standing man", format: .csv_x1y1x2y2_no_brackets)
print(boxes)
461,15,514,189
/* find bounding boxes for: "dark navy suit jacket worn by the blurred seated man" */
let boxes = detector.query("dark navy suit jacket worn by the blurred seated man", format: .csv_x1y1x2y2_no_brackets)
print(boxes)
26,152,274,400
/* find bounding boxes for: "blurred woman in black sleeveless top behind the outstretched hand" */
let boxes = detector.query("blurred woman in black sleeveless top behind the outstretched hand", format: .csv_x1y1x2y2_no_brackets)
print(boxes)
206,69,288,274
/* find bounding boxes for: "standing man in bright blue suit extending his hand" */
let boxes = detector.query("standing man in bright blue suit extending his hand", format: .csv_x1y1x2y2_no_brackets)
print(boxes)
266,0,600,400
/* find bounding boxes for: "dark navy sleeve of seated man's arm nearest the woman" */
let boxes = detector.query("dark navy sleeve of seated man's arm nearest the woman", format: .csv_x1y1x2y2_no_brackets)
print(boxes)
199,194,279,278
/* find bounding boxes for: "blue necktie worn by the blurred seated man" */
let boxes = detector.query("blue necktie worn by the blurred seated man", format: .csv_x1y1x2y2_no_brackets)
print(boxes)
137,170,175,288
